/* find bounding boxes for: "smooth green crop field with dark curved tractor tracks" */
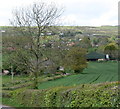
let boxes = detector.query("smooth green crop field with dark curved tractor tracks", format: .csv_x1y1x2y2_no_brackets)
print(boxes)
39,62,118,89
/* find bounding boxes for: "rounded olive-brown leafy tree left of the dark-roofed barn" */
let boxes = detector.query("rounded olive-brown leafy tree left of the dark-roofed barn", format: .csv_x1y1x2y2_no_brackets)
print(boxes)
64,47,87,73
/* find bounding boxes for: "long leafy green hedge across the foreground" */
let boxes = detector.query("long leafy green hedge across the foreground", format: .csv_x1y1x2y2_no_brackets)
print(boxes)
5,83,120,107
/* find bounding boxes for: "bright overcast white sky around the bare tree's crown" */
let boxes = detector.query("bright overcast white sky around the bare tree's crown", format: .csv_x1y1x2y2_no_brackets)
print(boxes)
0,0,119,26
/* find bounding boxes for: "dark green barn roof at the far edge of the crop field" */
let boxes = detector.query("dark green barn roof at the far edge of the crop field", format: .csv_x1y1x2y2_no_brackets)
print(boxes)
86,52,105,59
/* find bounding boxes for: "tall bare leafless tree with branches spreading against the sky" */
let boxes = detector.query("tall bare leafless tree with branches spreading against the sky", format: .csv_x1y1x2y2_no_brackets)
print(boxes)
10,2,63,88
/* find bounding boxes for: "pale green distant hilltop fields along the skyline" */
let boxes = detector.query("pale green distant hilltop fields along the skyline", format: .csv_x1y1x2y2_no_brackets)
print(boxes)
0,26,118,37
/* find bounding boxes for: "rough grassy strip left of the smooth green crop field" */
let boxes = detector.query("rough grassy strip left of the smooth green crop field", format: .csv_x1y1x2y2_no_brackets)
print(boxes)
2,75,63,90
